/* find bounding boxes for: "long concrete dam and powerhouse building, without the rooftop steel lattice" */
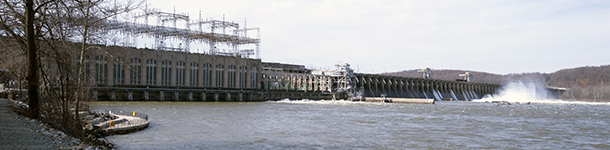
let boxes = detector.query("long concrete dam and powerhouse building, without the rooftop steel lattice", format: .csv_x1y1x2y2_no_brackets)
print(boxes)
63,43,512,101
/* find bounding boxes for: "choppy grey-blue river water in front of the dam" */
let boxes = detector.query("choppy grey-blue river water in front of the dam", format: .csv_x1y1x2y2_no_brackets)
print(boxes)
92,100,610,149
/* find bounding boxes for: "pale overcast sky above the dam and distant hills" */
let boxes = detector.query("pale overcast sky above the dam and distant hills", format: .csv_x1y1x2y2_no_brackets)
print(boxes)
141,0,610,74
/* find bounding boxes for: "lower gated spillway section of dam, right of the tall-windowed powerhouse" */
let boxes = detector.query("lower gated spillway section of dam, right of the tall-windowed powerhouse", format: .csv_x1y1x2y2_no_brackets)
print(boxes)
262,64,501,101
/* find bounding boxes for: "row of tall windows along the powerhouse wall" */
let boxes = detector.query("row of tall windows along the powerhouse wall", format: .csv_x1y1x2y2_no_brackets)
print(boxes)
85,56,257,88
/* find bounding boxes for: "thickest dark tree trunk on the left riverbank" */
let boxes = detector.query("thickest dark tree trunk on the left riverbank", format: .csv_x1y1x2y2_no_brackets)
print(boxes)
25,0,40,119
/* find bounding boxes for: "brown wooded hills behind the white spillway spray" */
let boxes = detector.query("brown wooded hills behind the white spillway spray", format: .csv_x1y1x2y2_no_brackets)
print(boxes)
384,65,610,101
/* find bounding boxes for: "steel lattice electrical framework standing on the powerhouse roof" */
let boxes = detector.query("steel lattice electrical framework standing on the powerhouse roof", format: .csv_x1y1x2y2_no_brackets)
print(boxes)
105,8,261,59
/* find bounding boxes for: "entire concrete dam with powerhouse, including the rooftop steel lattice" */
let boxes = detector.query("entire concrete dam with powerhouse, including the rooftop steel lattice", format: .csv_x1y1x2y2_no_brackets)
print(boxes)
4,9,561,101
